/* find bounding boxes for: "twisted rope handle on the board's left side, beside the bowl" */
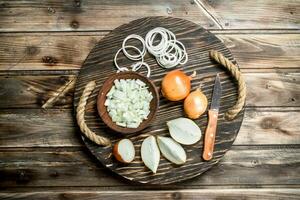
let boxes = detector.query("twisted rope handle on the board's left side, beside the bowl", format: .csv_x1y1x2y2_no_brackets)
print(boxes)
76,81,111,146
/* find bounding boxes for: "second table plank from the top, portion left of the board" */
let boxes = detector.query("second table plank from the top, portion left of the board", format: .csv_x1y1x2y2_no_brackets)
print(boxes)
0,34,103,70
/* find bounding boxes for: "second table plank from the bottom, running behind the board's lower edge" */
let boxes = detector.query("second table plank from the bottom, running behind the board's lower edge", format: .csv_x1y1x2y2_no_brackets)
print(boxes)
0,146,300,189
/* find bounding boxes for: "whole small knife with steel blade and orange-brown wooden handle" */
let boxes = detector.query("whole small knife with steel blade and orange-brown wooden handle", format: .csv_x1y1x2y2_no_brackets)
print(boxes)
202,74,222,161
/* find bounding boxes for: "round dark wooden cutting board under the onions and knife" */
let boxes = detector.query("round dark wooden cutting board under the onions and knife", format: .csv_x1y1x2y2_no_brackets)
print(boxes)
74,17,244,184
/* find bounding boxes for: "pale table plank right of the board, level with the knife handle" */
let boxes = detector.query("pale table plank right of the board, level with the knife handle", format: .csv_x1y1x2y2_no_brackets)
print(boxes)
234,108,300,145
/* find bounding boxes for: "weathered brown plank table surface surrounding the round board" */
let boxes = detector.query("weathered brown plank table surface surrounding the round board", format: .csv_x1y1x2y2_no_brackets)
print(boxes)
0,0,300,200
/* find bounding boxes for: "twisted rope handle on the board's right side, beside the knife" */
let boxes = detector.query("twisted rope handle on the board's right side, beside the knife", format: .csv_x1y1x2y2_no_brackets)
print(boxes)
209,50,246,120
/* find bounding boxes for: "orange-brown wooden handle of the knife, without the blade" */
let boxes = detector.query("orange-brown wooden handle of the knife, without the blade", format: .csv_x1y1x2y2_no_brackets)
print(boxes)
202,110,218,160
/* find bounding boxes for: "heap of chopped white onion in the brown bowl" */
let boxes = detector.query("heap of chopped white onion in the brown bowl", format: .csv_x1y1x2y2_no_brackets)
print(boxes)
104,79,153,128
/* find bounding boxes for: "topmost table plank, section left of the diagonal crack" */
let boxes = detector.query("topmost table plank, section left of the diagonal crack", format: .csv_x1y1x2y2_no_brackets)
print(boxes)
0,0,217,32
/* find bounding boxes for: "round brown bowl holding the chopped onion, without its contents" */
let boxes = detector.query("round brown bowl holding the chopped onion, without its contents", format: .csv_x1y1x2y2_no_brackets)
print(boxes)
97,71,159,134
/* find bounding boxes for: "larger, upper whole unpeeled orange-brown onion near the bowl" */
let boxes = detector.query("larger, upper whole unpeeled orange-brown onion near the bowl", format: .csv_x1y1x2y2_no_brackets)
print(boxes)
161,70,192,101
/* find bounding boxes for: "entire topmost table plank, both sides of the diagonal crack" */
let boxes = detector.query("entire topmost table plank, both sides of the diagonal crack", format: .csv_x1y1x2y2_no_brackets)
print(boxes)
0,0,299,32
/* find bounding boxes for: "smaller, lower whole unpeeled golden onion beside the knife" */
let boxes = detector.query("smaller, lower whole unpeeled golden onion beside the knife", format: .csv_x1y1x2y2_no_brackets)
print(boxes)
183,88,207,119
